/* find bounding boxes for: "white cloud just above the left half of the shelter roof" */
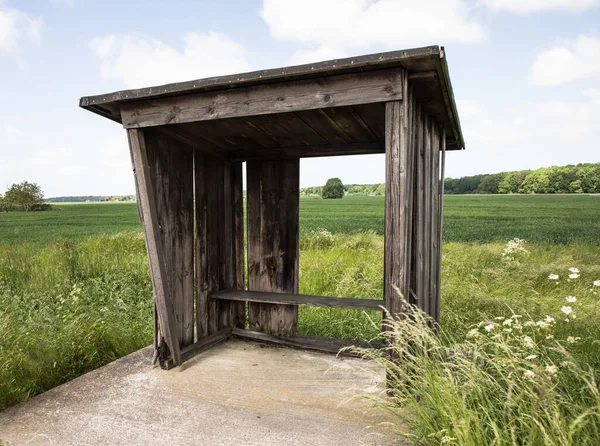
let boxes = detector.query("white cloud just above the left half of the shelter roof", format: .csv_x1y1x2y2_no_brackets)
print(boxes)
90,31,250,88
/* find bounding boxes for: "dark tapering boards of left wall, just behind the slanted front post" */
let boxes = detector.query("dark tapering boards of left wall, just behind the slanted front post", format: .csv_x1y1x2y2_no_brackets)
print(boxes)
144,129,194,348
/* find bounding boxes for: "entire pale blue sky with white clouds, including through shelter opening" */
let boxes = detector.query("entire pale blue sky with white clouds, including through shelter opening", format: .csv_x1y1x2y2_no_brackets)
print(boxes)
0,0,600,197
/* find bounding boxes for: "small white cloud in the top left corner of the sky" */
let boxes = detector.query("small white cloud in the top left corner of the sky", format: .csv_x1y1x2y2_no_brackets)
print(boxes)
0,0,44,53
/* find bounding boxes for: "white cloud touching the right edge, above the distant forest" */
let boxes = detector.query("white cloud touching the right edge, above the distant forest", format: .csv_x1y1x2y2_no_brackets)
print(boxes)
529,34,600,87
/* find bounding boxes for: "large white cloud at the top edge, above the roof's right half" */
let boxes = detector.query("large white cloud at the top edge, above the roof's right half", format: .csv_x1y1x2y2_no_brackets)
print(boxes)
260,0,485,62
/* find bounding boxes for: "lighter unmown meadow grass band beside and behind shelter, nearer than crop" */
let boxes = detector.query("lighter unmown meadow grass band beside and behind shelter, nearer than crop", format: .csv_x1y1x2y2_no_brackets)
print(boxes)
0,231,600,408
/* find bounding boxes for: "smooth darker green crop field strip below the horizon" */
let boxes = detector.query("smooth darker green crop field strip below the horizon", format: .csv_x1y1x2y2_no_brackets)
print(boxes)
0,195,600,245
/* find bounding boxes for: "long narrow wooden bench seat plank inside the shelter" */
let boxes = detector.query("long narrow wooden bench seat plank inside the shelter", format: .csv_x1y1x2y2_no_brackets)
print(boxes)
209,290,383,311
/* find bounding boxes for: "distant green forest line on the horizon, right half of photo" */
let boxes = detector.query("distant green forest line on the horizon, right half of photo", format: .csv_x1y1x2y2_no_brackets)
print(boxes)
300,163,600,196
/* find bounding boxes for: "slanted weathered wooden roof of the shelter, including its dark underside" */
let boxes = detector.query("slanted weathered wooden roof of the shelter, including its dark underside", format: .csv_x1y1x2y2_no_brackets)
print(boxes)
79,46,464,155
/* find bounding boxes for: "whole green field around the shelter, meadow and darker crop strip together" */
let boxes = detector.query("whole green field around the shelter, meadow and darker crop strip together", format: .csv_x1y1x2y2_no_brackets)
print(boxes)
0,196,600,422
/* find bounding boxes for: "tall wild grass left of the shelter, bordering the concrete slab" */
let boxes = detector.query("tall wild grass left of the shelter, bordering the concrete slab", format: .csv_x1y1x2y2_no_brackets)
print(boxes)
0,233,152,410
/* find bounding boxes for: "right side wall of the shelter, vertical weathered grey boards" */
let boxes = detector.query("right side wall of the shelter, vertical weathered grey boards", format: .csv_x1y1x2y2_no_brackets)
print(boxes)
384,75,445,321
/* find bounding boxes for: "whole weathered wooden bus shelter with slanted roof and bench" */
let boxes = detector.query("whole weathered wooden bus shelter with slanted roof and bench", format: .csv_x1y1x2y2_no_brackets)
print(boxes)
80,46,464,367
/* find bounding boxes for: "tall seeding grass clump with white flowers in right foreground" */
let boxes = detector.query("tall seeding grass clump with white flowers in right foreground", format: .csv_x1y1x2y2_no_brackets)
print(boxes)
354,305,600,446
